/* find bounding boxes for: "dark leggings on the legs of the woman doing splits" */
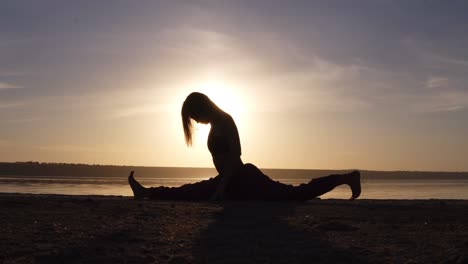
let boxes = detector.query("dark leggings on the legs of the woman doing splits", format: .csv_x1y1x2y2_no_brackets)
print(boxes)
149,164,342,201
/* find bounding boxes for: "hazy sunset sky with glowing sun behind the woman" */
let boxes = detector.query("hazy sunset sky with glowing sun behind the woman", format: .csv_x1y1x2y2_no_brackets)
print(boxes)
0,0,468,171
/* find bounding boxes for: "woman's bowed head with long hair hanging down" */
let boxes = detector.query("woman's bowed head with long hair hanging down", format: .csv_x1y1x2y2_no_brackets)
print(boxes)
181,92,221,146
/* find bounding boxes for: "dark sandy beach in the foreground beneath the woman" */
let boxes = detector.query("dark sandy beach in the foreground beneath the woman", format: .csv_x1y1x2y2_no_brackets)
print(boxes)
0,194,468,263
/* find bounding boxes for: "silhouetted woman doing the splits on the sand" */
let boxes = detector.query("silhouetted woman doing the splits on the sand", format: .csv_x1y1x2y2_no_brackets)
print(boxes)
128,92,361,201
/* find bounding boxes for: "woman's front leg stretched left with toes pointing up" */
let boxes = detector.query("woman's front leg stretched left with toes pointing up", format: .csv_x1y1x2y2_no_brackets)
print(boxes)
128,171,219,200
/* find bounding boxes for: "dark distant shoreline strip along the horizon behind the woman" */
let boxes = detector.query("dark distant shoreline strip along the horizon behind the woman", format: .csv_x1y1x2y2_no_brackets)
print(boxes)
0,162,468,179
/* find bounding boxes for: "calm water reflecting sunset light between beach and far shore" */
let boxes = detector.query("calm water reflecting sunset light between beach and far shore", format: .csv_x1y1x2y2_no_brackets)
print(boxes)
0,172,468,199
